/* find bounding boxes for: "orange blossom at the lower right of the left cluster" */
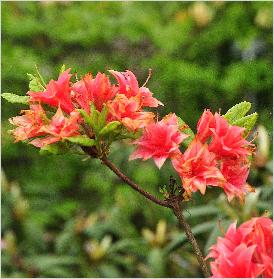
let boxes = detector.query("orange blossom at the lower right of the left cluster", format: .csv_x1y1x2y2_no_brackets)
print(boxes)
107,94,154,131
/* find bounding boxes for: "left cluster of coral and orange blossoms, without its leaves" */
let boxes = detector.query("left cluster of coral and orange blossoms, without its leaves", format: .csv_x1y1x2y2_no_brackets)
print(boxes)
10,69,162,148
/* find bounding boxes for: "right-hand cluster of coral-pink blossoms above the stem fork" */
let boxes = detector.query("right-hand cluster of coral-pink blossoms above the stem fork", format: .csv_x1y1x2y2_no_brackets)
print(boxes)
130,110,255,201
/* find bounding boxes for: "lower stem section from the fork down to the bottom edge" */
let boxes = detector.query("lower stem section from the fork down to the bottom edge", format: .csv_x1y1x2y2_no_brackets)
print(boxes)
172,200,210,277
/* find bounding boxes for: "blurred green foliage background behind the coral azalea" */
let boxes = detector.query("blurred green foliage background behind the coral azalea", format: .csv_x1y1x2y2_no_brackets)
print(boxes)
1,1,273,277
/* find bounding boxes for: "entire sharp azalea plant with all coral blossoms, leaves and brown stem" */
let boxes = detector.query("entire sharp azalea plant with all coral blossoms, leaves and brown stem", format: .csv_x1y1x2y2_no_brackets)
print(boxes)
2,65,273,278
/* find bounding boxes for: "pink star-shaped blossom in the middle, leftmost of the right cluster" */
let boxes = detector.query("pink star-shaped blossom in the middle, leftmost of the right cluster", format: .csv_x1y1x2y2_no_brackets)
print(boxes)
130,114,188,168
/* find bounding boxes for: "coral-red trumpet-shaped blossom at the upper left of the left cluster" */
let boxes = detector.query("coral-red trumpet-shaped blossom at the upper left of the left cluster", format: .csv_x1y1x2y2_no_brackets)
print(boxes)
28,69,74,113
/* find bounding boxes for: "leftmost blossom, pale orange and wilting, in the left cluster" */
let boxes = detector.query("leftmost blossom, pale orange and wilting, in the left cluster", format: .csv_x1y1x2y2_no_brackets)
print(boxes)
9,104,47,142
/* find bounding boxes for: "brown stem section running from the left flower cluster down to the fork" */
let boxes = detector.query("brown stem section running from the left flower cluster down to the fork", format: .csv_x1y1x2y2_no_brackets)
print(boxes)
101,157,171,207
